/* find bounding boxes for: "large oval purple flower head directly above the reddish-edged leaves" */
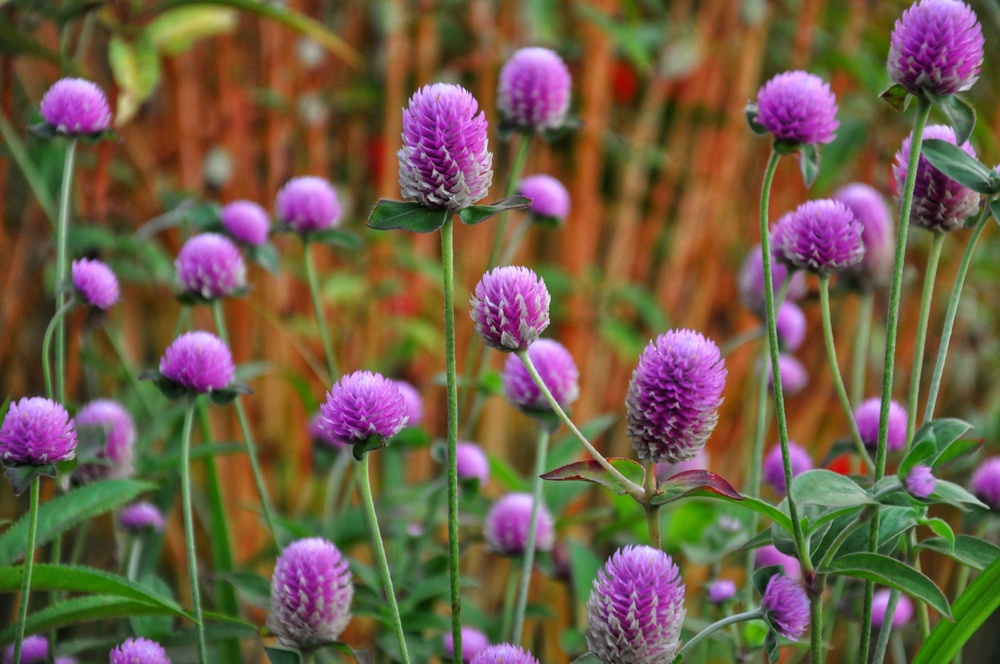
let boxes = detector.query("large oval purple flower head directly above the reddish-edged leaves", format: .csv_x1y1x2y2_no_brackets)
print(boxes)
625,330,726,463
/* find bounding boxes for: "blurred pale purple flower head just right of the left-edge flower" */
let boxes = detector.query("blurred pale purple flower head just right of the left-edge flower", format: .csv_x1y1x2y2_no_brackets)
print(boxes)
73,399,135,482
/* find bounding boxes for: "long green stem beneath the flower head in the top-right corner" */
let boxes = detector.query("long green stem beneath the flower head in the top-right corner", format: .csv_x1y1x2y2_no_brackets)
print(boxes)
858,97,932,664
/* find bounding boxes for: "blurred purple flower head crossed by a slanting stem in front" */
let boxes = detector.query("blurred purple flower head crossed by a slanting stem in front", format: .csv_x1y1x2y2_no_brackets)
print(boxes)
500,339,580,411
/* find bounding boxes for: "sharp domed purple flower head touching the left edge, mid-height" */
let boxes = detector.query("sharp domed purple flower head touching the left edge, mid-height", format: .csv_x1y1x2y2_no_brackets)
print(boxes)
0,397,76,466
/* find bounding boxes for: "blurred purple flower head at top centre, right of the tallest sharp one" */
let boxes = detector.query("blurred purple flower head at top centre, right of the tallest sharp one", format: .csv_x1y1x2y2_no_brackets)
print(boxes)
497,47,572,132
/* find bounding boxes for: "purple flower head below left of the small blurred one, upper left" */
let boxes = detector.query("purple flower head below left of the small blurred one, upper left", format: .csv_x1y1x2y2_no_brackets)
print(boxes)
174,233,247,300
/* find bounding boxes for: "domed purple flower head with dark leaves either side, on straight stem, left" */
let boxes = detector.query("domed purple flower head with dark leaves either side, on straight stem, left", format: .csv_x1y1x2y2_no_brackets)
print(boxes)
160,331,236,392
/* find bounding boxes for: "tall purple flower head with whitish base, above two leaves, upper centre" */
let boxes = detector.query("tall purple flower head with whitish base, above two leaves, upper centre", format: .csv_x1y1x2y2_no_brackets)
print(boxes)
396,83,493,211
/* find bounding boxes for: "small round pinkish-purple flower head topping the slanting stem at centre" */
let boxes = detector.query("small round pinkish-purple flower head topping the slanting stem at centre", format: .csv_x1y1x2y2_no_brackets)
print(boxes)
469,265,551,353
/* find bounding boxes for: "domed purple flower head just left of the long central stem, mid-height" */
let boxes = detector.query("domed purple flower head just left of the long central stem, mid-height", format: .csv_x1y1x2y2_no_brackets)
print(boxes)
320,371,407,444
